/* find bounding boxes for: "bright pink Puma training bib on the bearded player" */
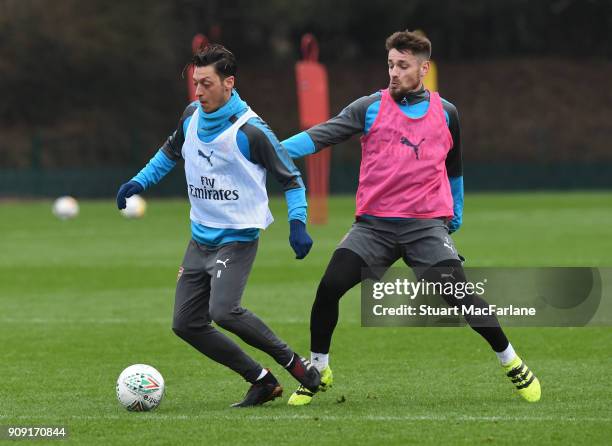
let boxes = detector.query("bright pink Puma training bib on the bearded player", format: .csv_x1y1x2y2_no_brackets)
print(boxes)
356,90,453,218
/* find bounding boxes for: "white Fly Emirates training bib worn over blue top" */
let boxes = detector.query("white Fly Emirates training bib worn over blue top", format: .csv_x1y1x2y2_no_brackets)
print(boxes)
182,108,274,229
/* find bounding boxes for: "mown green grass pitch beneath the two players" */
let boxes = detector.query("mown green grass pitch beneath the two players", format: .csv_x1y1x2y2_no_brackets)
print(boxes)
0,193,612,445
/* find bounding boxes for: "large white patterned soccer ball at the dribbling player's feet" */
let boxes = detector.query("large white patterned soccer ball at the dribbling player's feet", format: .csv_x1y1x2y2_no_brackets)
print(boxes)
117,364,164,412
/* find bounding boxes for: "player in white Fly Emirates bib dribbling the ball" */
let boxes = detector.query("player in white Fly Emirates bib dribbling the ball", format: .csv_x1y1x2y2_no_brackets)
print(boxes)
117,45,320,407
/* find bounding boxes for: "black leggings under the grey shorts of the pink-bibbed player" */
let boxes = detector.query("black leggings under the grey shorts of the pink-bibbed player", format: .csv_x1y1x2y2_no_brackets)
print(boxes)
310,248,508,353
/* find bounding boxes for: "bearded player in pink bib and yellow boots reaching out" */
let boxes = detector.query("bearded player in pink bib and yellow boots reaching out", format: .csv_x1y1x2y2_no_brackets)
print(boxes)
282,31,541,406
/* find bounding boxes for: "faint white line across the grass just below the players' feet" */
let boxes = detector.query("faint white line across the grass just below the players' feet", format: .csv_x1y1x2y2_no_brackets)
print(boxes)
0,412,612,423
